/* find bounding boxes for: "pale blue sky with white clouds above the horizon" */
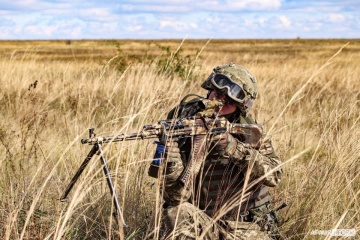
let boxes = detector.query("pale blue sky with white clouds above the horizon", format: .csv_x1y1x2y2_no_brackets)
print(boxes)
0,0,360,39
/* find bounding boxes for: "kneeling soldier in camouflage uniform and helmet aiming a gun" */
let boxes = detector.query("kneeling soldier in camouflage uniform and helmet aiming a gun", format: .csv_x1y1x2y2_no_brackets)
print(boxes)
153,63,282,240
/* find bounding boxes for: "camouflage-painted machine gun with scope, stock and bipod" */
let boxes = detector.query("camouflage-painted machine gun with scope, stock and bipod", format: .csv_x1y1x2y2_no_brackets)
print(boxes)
60,99,263,226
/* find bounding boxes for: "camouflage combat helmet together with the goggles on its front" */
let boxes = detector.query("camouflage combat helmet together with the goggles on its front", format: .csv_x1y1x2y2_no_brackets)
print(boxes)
201,62,257,112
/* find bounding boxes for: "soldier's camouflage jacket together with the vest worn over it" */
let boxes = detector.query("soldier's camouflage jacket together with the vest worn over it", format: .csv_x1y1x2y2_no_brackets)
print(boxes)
163,94,282,220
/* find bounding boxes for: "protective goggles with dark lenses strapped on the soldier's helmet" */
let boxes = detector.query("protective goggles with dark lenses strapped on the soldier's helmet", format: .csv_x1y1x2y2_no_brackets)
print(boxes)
210,73,247,103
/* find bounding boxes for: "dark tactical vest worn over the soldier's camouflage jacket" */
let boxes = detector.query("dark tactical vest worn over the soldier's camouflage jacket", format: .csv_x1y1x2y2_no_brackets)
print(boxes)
168,95,270,220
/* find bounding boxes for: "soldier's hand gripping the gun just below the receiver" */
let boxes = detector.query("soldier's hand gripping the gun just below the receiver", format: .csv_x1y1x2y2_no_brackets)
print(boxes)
210,132,238,156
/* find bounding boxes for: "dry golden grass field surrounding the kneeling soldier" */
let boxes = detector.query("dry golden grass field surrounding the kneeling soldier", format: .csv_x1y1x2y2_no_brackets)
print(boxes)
0,39,360,239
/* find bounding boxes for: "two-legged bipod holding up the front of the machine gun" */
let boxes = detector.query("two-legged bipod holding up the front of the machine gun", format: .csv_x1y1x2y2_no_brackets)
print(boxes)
60,128,127,227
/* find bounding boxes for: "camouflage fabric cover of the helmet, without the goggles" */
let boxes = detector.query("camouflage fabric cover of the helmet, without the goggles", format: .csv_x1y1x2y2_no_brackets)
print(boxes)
201,62,257,109
